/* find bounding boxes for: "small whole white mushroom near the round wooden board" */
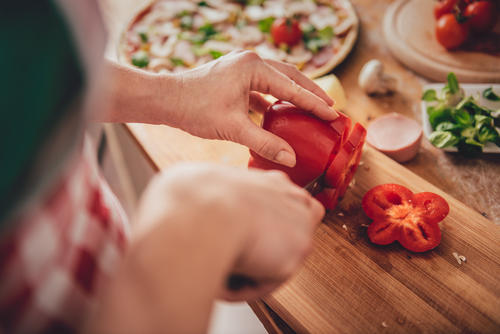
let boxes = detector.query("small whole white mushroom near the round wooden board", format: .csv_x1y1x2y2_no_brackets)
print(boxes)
358,59,396,95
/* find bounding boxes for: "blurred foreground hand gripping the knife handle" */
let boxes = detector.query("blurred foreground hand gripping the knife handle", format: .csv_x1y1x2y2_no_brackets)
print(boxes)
136,164,324,300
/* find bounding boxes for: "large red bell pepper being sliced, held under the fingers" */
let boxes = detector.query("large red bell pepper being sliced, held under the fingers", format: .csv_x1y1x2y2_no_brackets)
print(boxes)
248,101,366,209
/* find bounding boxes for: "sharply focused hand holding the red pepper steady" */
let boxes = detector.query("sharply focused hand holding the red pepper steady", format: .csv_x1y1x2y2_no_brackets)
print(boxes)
167,51,337,167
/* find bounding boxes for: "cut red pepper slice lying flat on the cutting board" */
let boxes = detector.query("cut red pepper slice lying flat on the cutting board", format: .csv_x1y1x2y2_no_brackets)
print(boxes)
362,184,450,252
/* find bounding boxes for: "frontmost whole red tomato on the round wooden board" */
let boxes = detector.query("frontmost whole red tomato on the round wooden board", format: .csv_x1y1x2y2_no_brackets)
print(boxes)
436,14,469,50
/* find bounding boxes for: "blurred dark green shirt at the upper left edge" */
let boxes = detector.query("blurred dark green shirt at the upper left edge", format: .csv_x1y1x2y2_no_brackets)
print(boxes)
0,0,84,222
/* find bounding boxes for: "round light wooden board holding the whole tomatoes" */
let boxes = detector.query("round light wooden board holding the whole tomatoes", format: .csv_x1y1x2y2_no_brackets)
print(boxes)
383,0,500,82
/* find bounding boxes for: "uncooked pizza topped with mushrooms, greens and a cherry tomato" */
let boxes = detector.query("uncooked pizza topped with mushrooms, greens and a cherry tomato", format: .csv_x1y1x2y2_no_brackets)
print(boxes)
119,0,359,78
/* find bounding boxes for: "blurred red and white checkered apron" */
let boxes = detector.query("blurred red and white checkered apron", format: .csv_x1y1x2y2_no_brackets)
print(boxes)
0,134,131,334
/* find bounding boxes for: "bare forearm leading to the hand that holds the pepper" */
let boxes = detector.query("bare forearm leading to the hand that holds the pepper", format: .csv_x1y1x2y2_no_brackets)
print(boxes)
89,59,182,124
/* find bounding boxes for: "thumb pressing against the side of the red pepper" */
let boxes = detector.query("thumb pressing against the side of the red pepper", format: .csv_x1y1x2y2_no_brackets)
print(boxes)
236,118,296,167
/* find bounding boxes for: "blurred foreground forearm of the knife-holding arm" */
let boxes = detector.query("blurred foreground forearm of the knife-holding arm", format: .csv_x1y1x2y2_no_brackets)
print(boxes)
89,207,246,333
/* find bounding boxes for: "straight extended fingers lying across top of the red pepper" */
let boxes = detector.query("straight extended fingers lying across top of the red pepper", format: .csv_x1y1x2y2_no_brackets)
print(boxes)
250,62,338,120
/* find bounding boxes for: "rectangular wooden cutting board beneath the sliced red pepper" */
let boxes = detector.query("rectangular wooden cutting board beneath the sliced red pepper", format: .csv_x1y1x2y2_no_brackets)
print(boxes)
128,124,500,333
